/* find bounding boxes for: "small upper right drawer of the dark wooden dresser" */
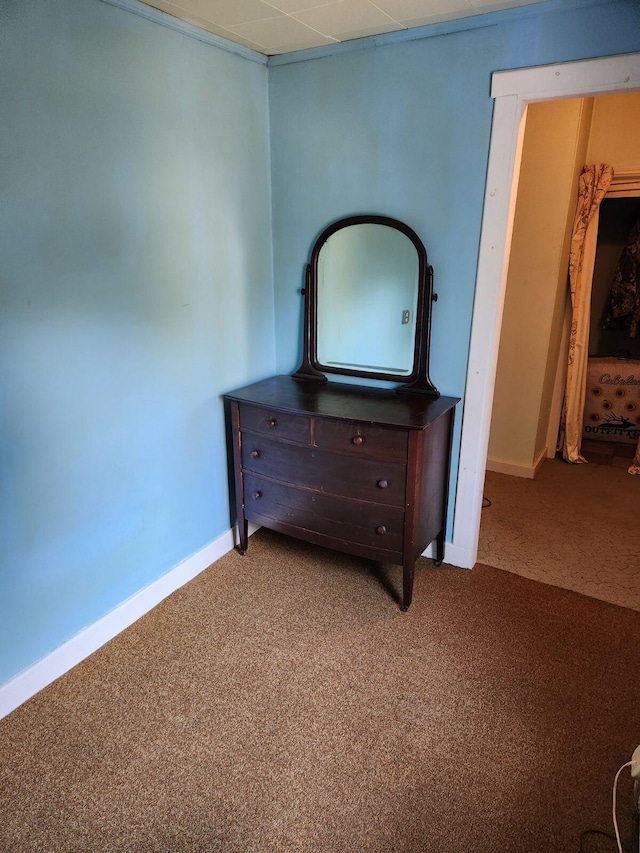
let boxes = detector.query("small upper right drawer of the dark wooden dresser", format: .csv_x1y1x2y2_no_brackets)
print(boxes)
314,418,408,462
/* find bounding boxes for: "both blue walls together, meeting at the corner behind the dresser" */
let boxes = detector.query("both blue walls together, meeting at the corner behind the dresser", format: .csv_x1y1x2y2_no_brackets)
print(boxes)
0,0,640,684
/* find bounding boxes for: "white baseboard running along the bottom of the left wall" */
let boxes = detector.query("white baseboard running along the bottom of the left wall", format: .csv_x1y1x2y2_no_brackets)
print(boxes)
0,524,258,719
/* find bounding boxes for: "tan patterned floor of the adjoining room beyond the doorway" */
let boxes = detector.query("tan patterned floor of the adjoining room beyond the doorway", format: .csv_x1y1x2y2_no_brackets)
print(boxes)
478,456,640,610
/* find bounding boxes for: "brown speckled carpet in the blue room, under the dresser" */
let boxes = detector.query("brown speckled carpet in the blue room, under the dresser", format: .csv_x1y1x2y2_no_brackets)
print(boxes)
0,530,640,853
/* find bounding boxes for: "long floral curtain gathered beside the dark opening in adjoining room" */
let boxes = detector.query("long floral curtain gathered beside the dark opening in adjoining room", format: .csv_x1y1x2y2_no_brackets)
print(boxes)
559,163,613,462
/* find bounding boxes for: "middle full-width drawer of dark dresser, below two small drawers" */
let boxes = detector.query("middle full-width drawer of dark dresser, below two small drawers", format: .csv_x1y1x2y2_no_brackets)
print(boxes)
241,433,406,507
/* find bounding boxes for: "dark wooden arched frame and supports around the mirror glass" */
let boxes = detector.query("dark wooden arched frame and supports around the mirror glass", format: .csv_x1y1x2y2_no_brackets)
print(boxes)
292,214,440,397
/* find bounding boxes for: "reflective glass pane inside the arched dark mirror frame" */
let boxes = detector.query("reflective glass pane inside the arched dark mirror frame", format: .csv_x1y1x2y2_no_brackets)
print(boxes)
316,222,420,377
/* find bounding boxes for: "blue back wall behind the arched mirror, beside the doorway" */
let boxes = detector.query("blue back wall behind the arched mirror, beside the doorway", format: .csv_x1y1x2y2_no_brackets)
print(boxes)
269,0,640,522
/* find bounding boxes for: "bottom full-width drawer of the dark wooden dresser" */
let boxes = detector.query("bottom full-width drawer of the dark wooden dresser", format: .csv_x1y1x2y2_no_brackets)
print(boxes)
244,473,404,553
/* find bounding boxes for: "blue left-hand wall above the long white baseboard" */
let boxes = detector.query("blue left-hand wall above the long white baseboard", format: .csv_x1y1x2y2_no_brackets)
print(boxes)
0,0,274,683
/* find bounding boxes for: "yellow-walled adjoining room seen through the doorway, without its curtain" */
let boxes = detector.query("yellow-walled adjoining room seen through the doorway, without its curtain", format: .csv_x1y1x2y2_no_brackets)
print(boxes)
478,92,640,610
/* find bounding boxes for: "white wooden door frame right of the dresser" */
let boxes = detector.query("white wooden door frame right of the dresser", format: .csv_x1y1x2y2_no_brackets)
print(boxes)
447,53,640,568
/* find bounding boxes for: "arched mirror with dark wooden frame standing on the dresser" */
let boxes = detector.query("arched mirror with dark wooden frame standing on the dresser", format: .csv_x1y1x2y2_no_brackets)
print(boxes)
293,215,438,397
